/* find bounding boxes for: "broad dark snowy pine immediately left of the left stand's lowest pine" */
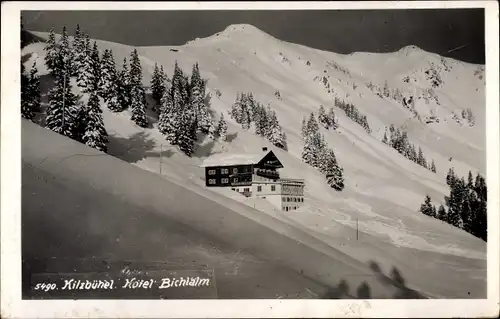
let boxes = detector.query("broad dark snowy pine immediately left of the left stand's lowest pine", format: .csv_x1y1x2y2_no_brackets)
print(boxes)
45,74,81,137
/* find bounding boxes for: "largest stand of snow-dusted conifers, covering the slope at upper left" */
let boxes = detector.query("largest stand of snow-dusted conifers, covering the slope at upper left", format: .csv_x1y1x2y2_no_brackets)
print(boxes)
21,25,227,156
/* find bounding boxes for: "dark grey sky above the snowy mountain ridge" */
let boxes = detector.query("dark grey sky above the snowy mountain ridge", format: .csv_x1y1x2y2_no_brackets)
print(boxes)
22,9,485,64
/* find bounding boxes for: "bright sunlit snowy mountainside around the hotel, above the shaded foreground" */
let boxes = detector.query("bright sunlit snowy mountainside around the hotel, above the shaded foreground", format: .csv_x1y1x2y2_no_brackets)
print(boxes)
23,25,486,298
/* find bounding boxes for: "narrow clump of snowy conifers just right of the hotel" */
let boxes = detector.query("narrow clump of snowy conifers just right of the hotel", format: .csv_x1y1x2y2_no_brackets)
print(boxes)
301,112,344,191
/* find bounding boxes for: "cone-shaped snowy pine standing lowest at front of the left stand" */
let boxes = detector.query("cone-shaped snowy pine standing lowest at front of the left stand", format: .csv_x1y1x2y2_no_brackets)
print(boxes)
82,92,108,152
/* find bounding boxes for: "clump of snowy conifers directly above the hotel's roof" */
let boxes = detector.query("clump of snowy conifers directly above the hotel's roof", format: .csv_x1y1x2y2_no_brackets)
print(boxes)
228,92,288,150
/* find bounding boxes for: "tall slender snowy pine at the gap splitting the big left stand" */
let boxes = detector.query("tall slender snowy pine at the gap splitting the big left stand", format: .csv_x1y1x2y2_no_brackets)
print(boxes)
130,49,148,127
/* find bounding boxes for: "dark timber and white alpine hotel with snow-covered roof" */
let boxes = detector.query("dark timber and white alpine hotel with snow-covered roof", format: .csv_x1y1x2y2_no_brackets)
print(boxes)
202,147,305,211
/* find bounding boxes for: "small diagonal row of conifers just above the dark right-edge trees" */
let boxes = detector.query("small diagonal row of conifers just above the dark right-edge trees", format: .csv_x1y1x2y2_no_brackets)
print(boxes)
382,124,436,173
